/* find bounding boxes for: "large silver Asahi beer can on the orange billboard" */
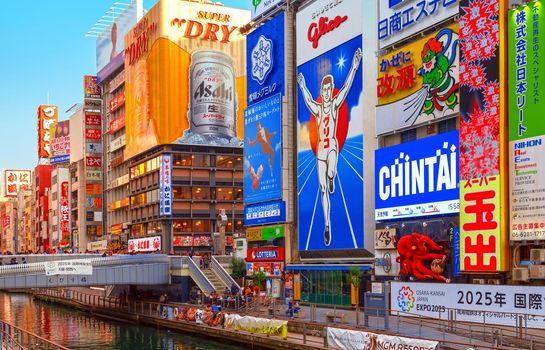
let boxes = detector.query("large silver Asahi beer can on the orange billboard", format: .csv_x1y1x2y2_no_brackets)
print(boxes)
188,50,237,138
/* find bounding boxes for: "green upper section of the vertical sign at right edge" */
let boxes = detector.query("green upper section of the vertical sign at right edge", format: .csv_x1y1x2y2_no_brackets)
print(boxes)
507,0,545,141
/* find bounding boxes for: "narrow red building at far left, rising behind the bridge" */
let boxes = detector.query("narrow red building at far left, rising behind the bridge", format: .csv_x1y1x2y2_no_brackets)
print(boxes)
32,164,52,252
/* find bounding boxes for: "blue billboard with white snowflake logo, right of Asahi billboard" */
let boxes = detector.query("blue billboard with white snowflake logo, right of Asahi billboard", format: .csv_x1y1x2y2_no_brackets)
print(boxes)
246,12,284,105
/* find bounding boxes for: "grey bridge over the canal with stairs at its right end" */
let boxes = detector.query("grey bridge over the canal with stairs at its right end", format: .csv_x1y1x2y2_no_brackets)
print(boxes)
0,254,240,296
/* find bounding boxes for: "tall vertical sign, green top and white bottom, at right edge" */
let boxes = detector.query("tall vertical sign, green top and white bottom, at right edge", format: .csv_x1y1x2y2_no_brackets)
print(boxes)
507,1,545,241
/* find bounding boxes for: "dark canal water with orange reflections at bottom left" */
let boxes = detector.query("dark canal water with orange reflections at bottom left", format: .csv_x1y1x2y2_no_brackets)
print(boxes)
0,292,244,350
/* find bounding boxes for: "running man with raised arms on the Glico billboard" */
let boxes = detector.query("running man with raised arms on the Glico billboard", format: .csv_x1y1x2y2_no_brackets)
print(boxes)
297,49,362,246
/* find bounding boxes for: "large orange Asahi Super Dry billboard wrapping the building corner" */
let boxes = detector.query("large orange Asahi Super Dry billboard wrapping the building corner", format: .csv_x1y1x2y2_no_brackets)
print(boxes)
125,0,250,158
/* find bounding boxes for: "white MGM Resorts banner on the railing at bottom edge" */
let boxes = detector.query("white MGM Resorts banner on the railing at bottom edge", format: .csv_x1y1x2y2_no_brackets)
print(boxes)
326,327,439,350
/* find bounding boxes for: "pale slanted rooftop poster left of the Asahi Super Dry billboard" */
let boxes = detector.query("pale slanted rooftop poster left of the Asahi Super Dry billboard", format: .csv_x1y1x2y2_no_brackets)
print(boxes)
96,0,144,84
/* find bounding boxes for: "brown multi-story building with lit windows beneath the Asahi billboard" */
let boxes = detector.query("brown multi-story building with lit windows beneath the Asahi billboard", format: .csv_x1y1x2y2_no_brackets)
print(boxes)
129,145,244,254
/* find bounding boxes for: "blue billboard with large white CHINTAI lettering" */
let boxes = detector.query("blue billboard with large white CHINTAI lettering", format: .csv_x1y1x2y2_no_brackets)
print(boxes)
375,131,460,221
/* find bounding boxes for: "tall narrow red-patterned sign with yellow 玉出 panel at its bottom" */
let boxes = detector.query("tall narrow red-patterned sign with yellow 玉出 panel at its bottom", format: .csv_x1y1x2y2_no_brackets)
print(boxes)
459,0,508,272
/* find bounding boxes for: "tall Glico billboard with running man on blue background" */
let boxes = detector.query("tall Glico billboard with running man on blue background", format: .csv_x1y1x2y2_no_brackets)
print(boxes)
296,0,364,251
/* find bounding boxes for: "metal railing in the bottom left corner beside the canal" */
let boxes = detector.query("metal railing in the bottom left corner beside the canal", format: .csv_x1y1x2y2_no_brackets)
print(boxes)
0,321,68,350
